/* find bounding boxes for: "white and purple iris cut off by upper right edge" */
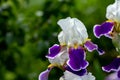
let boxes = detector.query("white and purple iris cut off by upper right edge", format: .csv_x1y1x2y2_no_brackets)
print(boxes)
93,0,120,53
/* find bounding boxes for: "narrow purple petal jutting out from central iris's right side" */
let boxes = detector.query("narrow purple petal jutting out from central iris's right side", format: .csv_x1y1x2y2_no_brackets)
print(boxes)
84,41,104,55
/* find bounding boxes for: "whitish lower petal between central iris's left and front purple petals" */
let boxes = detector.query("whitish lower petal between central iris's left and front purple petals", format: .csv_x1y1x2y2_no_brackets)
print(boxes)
49,47,69,66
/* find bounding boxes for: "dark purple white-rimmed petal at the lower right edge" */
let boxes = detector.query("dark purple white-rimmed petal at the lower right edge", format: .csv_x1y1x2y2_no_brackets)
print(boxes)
102,58,120,72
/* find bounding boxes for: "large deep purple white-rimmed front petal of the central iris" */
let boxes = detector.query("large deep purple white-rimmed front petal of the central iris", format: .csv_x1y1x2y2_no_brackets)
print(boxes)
67,47,88,71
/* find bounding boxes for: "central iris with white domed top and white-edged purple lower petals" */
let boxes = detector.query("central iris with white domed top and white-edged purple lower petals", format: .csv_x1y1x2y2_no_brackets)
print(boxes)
39,17,104,80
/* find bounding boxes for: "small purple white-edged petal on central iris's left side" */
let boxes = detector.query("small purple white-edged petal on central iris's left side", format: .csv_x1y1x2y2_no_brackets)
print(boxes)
46,44,61,59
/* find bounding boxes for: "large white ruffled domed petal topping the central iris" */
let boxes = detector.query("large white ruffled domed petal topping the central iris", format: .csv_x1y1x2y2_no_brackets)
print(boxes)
58,17,88,45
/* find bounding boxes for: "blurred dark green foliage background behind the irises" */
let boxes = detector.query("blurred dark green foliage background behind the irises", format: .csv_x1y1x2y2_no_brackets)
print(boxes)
0,0,117,80
